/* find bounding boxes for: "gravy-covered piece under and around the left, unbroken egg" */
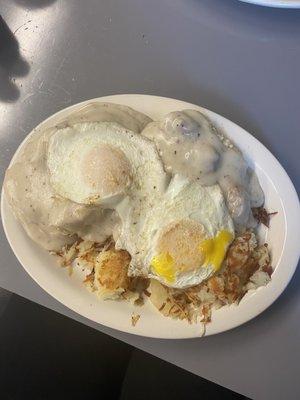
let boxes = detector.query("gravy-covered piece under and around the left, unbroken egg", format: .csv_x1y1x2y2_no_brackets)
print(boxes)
4,103,150,250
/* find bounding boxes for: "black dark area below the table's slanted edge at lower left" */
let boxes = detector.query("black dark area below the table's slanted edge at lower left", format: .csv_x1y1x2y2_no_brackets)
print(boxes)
0,295,245,400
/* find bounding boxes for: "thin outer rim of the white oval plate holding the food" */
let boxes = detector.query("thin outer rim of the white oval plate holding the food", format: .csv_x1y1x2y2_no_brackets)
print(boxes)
1,94,300,339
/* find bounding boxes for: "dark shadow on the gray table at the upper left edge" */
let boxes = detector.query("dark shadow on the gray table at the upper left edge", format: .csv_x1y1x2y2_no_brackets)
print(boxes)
0,16,30,102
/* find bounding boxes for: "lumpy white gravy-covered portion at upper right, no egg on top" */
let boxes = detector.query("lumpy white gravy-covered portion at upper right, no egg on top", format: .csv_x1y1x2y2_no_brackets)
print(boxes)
142,110,264,229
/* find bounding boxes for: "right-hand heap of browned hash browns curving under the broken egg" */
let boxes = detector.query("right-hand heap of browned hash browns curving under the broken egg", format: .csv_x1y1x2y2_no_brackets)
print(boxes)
149,231,271,323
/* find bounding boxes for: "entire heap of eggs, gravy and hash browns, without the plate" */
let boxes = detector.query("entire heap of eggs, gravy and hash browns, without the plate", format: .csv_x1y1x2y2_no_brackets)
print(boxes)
5,102,272,326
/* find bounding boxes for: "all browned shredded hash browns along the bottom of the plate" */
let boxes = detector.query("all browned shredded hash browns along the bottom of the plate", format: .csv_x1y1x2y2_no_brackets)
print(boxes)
58,231,272,326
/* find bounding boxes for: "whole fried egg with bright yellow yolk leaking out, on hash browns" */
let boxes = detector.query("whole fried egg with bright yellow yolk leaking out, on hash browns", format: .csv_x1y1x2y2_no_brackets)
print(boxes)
117,175,234,288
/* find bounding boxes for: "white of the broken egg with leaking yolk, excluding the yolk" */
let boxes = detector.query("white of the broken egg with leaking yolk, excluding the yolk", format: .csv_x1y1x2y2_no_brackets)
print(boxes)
117,175,234,288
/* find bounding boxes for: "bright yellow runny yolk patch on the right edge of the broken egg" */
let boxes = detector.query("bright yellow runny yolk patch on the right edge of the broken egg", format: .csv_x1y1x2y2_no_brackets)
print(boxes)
199,230,233,271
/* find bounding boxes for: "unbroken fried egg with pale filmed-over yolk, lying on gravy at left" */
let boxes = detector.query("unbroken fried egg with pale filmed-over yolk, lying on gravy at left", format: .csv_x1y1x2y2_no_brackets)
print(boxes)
47,122,167,209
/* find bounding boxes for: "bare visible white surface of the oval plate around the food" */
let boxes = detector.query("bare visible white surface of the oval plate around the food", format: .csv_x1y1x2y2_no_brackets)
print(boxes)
1,94,300,339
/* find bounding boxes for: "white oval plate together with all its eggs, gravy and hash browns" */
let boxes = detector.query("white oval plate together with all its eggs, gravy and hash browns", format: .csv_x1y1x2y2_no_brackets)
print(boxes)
1,94,300,339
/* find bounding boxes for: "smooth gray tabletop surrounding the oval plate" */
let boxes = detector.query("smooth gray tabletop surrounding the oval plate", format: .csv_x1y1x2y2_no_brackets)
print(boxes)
0,0,300,400
